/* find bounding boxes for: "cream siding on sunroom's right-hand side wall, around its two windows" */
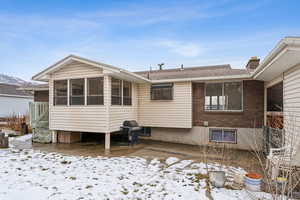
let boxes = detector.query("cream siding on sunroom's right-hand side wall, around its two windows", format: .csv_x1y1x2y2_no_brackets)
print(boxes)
109,84,138,131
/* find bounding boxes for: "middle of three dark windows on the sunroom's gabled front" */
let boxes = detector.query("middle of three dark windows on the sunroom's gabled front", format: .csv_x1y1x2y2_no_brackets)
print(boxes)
70,79,84,105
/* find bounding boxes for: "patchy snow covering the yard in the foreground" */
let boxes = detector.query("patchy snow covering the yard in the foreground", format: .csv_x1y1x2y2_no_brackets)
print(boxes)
0,136,268,200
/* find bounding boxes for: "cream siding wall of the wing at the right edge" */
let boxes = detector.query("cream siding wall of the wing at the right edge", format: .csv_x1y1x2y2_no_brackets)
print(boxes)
283,65,300,145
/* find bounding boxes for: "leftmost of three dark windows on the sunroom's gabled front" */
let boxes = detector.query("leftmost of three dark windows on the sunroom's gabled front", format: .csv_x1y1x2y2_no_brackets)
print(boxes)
53,80,68,105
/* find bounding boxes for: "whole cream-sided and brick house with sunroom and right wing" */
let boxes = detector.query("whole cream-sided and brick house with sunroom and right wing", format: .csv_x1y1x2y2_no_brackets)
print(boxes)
29,37,300,149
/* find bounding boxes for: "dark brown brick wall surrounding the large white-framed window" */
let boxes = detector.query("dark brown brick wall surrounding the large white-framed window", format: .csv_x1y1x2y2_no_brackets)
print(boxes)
193,80,264,128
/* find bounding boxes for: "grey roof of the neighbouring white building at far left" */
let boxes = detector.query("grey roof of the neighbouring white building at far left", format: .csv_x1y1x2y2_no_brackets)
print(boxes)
0,83,32,98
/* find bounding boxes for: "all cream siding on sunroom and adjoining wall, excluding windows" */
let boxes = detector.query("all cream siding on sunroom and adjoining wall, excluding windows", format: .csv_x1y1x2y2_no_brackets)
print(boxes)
49,61,192,133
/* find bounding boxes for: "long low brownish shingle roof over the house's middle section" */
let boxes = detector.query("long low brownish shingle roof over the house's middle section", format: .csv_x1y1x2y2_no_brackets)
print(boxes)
135,65,250,80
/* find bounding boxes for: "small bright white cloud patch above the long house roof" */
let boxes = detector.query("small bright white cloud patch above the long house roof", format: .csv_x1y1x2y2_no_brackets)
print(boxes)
158,40,202,57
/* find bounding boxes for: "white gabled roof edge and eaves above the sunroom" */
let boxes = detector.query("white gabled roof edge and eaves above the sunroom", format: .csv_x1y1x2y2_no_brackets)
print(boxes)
32,55,150,83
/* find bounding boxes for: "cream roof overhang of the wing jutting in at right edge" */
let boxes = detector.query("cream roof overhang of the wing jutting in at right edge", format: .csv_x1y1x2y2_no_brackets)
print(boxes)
252,37,300,81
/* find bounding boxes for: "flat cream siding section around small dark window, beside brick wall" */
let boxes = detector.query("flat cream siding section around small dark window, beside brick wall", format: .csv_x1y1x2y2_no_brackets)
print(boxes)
138,82,192,128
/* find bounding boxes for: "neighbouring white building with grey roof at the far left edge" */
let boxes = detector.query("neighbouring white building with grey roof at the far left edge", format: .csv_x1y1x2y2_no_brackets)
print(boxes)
0,83,33,118
